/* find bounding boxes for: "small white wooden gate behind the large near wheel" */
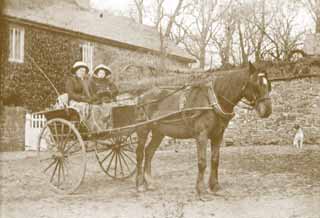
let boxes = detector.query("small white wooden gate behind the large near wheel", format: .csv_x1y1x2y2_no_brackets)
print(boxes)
25,113,47,151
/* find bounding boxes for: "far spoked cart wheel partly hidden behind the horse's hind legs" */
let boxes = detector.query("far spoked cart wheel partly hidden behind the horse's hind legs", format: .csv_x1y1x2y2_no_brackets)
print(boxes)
96,133,137,180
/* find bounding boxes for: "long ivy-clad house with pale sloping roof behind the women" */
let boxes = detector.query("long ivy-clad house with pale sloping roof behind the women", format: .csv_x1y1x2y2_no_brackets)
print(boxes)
0,0,194,110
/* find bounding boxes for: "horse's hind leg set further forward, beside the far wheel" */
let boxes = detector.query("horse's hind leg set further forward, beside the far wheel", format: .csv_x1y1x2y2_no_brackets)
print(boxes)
144,131,164,190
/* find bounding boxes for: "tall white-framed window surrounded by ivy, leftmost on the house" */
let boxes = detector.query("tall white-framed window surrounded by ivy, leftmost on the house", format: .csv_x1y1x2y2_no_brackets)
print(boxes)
9,27,24,63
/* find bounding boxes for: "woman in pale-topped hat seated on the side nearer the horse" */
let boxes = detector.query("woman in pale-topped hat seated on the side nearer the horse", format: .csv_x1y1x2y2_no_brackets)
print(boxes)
91,64,119,103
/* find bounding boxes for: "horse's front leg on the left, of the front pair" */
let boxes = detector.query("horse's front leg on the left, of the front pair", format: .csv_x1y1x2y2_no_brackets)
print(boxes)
196,131,208,197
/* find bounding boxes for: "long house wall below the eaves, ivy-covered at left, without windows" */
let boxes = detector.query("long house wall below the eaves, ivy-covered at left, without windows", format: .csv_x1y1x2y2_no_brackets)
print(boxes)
0,20,186,111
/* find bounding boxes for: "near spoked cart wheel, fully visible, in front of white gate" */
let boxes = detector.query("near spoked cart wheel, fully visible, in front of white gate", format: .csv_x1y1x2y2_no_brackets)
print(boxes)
38,118,86,194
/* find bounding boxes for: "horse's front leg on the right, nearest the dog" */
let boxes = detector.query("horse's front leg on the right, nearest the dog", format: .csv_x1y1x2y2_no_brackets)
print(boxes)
209,133,223,193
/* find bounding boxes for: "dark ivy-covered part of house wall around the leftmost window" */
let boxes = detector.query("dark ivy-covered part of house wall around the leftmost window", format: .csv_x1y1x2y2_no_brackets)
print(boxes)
1,20,81,111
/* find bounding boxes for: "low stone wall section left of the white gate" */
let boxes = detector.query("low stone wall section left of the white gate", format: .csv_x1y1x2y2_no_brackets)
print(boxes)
0,107,26,151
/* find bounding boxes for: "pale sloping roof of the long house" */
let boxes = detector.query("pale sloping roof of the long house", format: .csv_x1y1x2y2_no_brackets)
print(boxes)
3,0,195,62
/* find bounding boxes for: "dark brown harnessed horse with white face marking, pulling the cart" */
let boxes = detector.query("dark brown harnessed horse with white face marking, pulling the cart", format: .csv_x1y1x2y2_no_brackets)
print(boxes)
136,63,272,195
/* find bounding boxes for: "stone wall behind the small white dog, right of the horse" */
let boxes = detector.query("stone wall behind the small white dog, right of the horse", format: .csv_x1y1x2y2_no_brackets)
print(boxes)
225,78,320,145
